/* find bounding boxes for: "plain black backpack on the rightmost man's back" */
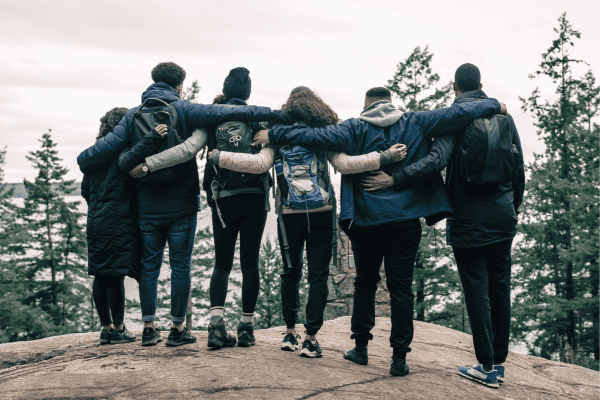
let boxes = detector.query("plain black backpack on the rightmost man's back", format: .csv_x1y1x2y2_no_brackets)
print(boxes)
453,114,518,185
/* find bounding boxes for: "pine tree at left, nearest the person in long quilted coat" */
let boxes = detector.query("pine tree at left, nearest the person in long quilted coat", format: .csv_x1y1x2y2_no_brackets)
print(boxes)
19,131,90,332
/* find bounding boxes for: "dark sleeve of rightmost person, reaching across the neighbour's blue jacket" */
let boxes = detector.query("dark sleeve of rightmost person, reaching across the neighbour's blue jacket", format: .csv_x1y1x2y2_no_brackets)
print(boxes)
393,135,456,188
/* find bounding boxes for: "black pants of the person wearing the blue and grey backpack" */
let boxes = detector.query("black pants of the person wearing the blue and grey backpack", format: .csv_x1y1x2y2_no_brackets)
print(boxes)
277,211,333,335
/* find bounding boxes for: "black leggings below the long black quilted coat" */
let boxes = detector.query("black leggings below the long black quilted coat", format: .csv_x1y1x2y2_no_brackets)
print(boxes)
93,276,125,327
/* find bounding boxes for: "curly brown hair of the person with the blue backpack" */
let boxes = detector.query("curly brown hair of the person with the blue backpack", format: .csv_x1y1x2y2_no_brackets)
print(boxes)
281,87,340,128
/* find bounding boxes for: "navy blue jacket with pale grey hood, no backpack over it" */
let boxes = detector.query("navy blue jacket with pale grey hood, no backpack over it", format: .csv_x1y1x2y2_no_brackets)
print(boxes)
269,99,500,229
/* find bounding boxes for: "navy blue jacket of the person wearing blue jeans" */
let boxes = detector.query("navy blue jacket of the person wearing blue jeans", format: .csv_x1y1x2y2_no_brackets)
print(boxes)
77,82,271,218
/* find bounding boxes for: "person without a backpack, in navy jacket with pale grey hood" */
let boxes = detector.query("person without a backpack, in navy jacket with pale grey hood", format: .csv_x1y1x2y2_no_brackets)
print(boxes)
255,87,506,376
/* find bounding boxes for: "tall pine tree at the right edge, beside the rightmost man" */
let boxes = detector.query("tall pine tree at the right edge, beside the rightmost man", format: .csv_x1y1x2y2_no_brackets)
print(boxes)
512,14,599,365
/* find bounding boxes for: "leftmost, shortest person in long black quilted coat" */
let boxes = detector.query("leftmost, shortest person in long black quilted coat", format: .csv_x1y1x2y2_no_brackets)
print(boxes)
81,108,166,344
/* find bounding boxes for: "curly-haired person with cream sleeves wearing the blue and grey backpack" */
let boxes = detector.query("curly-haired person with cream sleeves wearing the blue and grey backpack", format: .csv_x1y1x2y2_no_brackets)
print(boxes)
209,86,406,358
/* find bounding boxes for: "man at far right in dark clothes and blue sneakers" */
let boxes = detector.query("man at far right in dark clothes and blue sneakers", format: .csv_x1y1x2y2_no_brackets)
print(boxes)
360,64,525,387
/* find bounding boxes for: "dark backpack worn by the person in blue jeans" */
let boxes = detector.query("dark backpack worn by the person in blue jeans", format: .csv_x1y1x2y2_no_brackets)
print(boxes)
132,98,183,185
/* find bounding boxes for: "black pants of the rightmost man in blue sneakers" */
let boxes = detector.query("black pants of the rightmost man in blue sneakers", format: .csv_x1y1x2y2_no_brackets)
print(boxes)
452,239,512,365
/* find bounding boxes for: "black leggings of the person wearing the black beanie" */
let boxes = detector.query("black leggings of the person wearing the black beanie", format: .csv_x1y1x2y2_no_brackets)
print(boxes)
210,193,267,313
